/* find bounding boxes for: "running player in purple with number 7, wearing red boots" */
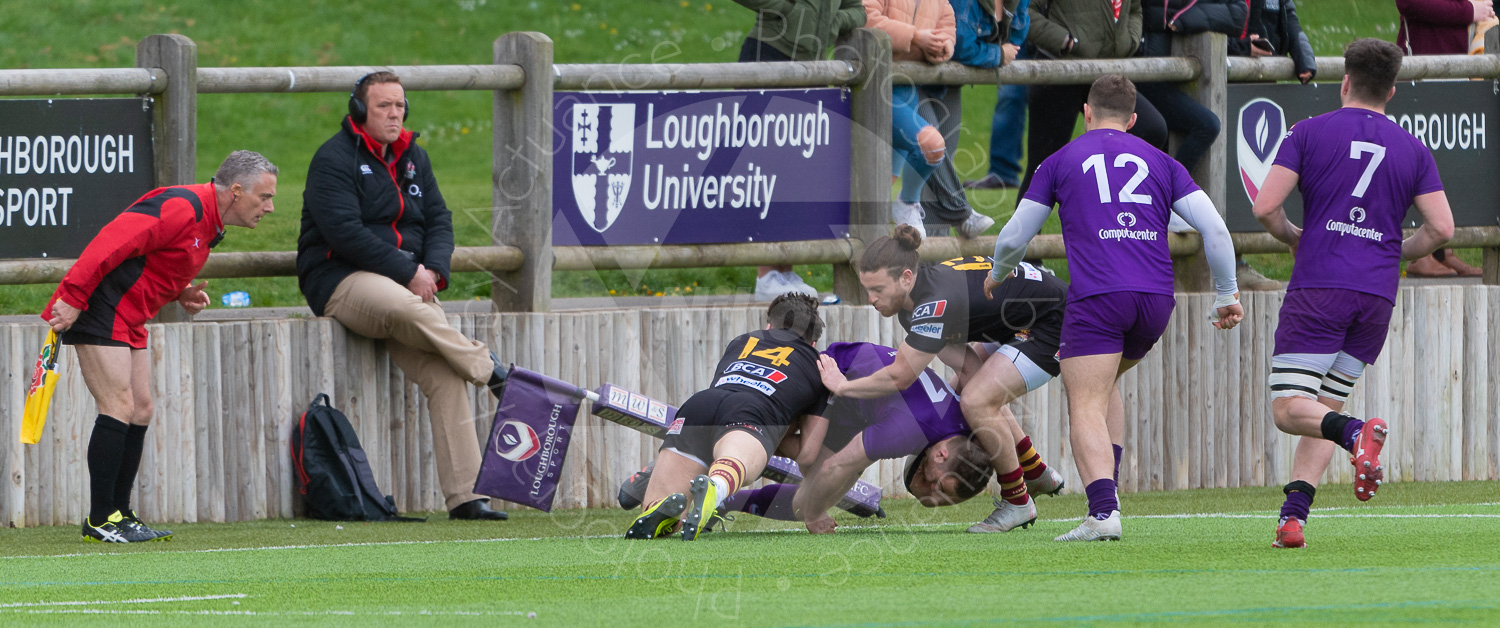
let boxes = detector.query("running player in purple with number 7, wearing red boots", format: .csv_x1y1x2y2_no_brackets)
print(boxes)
1254,39,1454,547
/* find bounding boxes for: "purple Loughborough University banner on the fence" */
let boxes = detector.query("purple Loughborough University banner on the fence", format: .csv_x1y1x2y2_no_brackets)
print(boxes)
552,88,849,246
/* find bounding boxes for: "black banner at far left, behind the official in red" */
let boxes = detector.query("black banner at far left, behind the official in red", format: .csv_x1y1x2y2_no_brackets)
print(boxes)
0,99,155,258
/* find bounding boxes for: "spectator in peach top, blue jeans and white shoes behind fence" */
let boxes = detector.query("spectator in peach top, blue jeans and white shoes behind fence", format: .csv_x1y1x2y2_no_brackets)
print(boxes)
864,0,995,238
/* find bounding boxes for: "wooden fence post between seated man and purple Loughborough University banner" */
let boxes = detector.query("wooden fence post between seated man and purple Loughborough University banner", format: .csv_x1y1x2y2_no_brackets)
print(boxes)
491,33,552,312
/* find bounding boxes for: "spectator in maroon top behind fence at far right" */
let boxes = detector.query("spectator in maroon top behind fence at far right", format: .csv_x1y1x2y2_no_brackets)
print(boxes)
1397,0,1496,277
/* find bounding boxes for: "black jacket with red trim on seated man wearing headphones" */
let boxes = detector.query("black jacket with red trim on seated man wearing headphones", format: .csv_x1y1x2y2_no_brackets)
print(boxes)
297,117,453,316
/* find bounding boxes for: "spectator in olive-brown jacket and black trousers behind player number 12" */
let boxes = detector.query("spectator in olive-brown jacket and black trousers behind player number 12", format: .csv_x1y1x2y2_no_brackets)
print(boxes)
1016,0,1167,204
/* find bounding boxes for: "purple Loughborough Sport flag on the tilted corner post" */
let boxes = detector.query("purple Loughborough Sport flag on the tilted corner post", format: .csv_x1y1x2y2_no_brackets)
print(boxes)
474,366,582,513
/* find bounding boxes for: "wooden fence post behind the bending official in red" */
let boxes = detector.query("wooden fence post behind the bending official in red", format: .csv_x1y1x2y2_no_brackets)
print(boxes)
139,34,198,322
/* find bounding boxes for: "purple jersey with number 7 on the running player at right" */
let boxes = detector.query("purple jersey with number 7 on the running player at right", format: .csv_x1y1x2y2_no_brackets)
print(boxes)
1275,108,1443,303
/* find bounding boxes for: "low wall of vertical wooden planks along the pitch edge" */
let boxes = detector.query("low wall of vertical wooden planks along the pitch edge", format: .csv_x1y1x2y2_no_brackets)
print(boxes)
0,286,1500,526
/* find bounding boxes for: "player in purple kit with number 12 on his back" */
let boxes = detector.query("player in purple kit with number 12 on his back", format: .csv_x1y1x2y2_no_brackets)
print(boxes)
986,75,1244,541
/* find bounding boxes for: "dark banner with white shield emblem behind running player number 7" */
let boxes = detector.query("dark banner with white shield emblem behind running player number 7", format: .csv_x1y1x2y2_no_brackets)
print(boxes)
1224,81,1500,231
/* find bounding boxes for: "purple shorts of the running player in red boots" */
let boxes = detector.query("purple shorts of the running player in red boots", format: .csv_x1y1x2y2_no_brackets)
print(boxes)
1277,288,1395,364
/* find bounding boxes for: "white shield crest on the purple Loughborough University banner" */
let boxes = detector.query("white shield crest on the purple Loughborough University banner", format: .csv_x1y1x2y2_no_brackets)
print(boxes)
573,103,636,234
